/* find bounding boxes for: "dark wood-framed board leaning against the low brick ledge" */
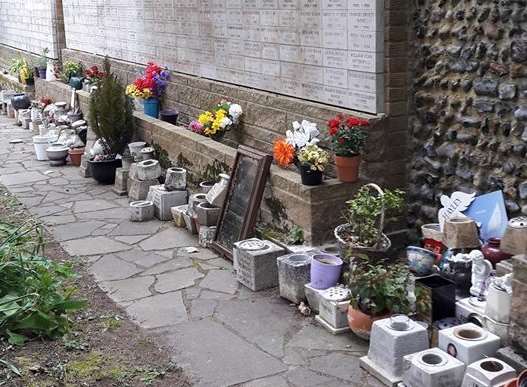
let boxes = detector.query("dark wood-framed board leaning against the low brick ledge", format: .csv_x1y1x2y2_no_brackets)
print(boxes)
212,145,272,259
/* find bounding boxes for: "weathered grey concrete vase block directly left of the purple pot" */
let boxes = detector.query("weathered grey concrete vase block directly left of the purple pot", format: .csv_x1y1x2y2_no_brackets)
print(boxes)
277,253,311,304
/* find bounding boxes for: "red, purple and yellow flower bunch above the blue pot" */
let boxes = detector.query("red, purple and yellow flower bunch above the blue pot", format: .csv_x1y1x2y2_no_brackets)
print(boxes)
126,62,170,100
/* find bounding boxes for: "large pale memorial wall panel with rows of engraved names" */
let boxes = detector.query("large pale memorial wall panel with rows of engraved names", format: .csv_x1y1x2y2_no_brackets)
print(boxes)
64,0,384,113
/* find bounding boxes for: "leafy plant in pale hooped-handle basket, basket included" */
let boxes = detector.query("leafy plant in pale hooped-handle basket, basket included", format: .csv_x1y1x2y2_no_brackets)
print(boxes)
334,183,404,256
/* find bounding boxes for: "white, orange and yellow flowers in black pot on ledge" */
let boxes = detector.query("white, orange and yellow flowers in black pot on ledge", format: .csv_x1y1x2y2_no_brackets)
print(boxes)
273,120,329,185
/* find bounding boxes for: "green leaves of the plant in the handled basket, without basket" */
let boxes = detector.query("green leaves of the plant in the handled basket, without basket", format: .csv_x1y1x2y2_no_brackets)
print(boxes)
344,185,405,247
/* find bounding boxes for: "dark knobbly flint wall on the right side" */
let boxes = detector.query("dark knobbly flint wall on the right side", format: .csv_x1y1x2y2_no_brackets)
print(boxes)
409,0,527,230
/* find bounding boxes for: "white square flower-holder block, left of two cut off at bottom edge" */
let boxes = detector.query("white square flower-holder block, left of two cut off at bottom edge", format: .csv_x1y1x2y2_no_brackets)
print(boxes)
403,348,465,387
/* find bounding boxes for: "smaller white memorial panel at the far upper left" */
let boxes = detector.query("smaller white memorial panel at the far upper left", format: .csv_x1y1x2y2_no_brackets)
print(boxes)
0,0,64,64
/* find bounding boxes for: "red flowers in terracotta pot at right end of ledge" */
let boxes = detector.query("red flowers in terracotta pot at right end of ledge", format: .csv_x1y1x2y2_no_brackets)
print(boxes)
328,115,369,183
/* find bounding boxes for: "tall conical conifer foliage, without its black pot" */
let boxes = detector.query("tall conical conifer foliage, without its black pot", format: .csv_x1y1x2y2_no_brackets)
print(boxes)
89,58,134,158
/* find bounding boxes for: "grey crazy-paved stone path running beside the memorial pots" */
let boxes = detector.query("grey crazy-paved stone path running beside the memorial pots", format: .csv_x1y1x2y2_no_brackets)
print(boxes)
0,116,379,387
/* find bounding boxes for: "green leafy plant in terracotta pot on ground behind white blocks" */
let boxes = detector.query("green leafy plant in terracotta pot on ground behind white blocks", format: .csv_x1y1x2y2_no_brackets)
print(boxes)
348,259,411,340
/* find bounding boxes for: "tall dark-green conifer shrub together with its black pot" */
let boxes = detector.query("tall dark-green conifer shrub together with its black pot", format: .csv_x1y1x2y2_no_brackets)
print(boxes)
89,58,134,184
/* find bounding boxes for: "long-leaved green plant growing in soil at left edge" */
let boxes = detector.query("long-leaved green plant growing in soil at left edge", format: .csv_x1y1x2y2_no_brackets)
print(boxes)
0,223,85,344
